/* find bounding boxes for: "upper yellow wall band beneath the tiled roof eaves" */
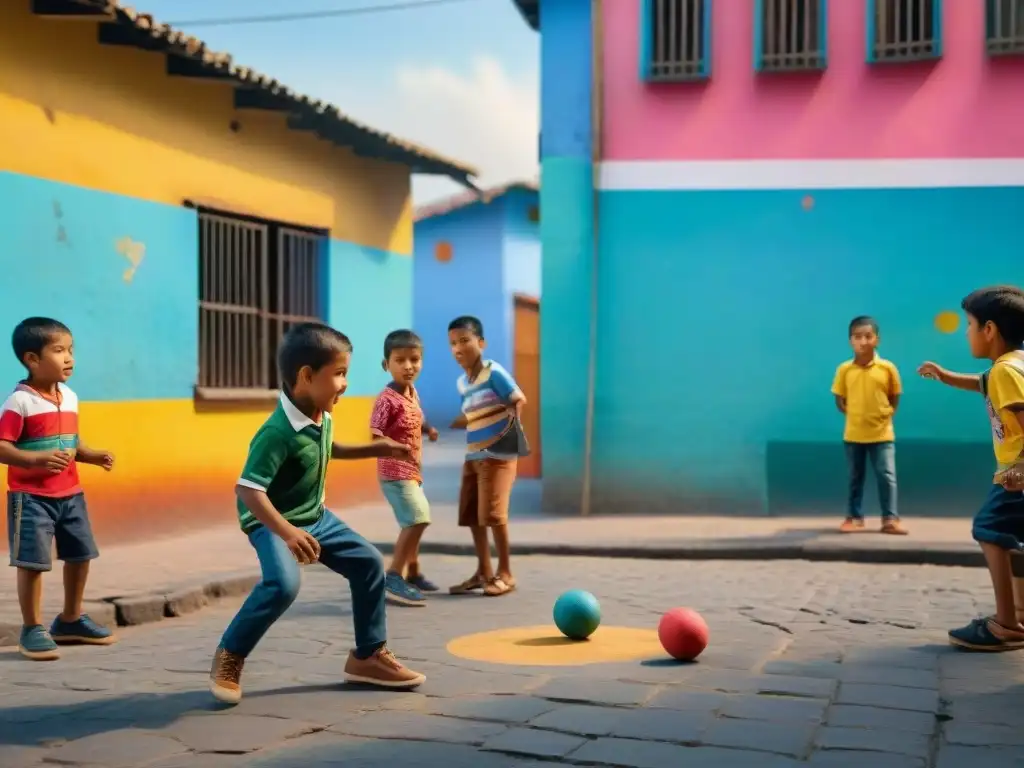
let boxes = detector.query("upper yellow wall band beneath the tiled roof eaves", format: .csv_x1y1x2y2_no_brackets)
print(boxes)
0,0,413,254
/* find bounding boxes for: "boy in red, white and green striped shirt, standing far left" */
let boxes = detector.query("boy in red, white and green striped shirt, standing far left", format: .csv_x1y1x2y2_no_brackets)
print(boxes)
0,317,117,662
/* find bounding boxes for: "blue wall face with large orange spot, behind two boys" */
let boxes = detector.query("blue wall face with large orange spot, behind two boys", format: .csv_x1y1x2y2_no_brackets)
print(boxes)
413,202,509,426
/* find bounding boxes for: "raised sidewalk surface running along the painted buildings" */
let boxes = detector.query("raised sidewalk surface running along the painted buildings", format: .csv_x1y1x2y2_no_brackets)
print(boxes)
0,505,983,646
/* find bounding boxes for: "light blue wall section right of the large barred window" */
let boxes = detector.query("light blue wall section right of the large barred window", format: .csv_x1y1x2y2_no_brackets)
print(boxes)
327,240,414,396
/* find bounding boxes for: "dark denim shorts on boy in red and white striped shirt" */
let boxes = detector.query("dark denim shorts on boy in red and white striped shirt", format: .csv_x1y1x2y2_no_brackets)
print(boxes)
7,490,99,570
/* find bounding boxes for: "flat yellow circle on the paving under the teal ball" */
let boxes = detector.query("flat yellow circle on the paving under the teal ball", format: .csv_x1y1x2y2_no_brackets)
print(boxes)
447,626,665,667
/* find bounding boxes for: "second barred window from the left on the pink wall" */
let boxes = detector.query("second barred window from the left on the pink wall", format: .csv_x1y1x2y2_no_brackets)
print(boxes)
754,0,828,72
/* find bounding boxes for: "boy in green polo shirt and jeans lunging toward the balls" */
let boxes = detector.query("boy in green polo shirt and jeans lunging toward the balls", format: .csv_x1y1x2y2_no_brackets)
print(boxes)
210,323,425,703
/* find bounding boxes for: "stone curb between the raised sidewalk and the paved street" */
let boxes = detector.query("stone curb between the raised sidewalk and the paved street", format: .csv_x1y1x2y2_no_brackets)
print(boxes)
0,541,985,647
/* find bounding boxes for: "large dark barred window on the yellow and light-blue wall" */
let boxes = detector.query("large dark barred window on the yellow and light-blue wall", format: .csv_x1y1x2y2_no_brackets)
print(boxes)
196,210,327,399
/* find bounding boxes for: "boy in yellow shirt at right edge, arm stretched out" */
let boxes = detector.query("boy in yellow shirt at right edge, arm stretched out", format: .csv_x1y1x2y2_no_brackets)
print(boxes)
918,286,1024,651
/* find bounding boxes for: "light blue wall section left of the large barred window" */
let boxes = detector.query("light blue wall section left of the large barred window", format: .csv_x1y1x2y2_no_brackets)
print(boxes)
0,173,199,400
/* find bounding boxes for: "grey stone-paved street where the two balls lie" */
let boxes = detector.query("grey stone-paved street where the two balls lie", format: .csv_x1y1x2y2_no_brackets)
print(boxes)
0,557,1024,768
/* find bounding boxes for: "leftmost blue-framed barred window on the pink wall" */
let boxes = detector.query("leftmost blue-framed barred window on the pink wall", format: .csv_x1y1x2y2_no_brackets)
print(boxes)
640,0,711,83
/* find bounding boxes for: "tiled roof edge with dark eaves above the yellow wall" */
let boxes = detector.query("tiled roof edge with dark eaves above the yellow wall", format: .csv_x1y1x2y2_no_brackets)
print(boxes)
59,0,477,189
